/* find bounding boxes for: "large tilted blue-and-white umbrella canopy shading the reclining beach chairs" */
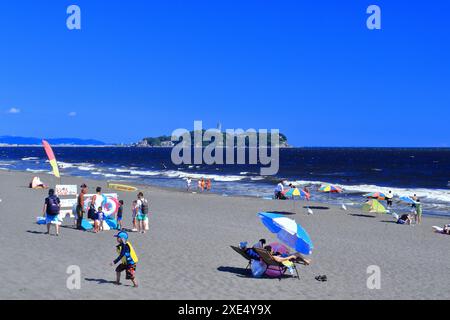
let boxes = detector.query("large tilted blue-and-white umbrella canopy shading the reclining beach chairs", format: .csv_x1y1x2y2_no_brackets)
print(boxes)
258,212,314,255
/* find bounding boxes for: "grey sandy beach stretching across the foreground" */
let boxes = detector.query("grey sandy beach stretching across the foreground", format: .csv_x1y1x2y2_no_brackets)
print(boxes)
0,171,450,300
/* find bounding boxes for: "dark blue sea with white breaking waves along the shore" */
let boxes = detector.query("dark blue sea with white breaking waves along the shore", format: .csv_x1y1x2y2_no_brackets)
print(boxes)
0,147,450,216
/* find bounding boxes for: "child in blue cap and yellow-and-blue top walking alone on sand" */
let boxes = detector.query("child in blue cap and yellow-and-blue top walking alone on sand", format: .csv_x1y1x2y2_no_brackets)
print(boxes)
111,231,139,288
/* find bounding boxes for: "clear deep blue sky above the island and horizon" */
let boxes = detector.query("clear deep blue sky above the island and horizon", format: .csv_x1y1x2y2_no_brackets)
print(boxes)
0,0,450,146
